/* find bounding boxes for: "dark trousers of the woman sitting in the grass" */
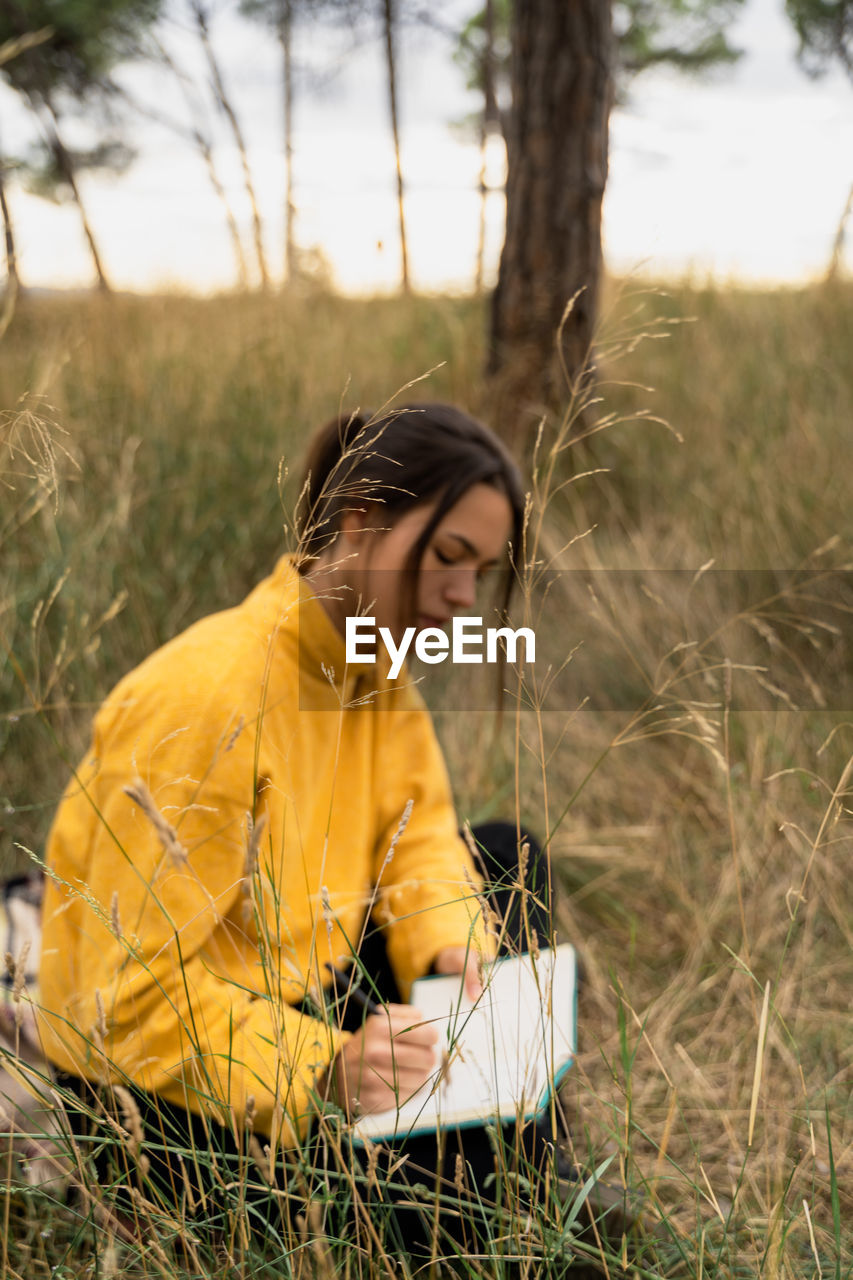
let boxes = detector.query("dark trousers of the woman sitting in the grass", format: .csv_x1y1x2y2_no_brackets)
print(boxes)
59,823,562,1257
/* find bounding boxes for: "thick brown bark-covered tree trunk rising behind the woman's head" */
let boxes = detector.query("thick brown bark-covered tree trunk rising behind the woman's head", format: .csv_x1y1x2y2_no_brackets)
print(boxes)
488,0,612,436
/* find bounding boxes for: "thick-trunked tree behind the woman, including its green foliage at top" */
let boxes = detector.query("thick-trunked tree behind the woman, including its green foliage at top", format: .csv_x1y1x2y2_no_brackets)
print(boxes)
479,0,744,433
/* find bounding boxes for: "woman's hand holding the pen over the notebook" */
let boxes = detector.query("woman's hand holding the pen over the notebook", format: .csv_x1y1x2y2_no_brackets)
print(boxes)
329,1005,438,1115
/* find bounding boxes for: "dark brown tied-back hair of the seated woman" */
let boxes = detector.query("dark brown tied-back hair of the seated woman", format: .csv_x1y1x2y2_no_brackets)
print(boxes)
297,402,525,629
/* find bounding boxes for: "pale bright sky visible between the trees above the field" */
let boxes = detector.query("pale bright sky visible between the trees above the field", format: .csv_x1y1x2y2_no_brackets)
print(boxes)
0,0,853,293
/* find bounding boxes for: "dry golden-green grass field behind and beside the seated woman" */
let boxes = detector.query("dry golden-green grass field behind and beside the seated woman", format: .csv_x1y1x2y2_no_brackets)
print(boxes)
0,283,853,1280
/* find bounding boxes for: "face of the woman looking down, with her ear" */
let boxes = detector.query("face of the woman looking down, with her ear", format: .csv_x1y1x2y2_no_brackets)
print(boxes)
341,484,512,639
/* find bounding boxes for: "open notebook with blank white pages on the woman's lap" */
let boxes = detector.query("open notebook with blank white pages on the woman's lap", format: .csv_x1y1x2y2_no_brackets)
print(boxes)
353,943,576,1140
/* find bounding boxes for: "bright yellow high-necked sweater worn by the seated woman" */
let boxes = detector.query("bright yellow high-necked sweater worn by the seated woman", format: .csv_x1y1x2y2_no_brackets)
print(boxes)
41,558,483,1142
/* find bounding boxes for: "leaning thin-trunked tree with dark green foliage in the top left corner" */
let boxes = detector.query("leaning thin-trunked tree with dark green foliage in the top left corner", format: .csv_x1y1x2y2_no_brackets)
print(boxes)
0,0,161,289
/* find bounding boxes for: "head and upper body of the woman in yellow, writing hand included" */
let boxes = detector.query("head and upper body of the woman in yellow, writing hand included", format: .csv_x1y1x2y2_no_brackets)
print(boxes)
41,404,558,1259
